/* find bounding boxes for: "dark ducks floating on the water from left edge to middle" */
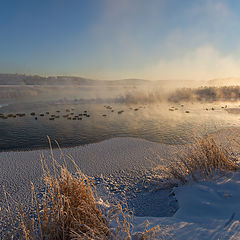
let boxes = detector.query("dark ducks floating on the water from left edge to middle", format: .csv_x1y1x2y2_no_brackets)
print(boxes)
0,105,143,121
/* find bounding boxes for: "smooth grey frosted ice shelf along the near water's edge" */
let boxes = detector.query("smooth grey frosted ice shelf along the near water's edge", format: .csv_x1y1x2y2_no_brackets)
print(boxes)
0,138,178,213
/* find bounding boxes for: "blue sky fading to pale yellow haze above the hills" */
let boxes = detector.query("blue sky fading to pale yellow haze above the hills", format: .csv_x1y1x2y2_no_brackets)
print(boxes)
0,0,240,80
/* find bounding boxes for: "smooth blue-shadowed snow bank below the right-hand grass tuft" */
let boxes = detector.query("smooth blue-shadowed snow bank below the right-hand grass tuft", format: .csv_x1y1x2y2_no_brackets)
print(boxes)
134,172,240,240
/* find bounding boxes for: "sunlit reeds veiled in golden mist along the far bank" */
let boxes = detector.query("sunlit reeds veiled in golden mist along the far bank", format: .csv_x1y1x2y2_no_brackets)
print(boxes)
63,86,240,104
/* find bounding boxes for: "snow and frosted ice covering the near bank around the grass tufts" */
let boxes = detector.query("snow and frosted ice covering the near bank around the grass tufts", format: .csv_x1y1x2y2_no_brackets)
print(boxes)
0,129,240,240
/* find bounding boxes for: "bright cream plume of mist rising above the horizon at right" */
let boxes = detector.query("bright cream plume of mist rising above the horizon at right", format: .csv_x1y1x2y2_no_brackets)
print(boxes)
139,45,240,81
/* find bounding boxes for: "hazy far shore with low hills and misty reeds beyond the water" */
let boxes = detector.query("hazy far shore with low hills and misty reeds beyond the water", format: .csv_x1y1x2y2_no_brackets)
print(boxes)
0,74,240,104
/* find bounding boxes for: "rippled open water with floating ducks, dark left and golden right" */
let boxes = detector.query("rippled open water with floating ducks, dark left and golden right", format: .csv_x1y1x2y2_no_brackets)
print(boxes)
0,100,240,151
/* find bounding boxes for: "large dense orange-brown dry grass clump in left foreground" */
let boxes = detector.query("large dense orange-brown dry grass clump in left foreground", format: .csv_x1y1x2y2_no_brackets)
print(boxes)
14,157,110,240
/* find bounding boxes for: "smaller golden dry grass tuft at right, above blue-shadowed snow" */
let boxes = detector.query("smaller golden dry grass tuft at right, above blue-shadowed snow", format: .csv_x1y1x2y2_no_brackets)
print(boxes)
168,136,240,183
